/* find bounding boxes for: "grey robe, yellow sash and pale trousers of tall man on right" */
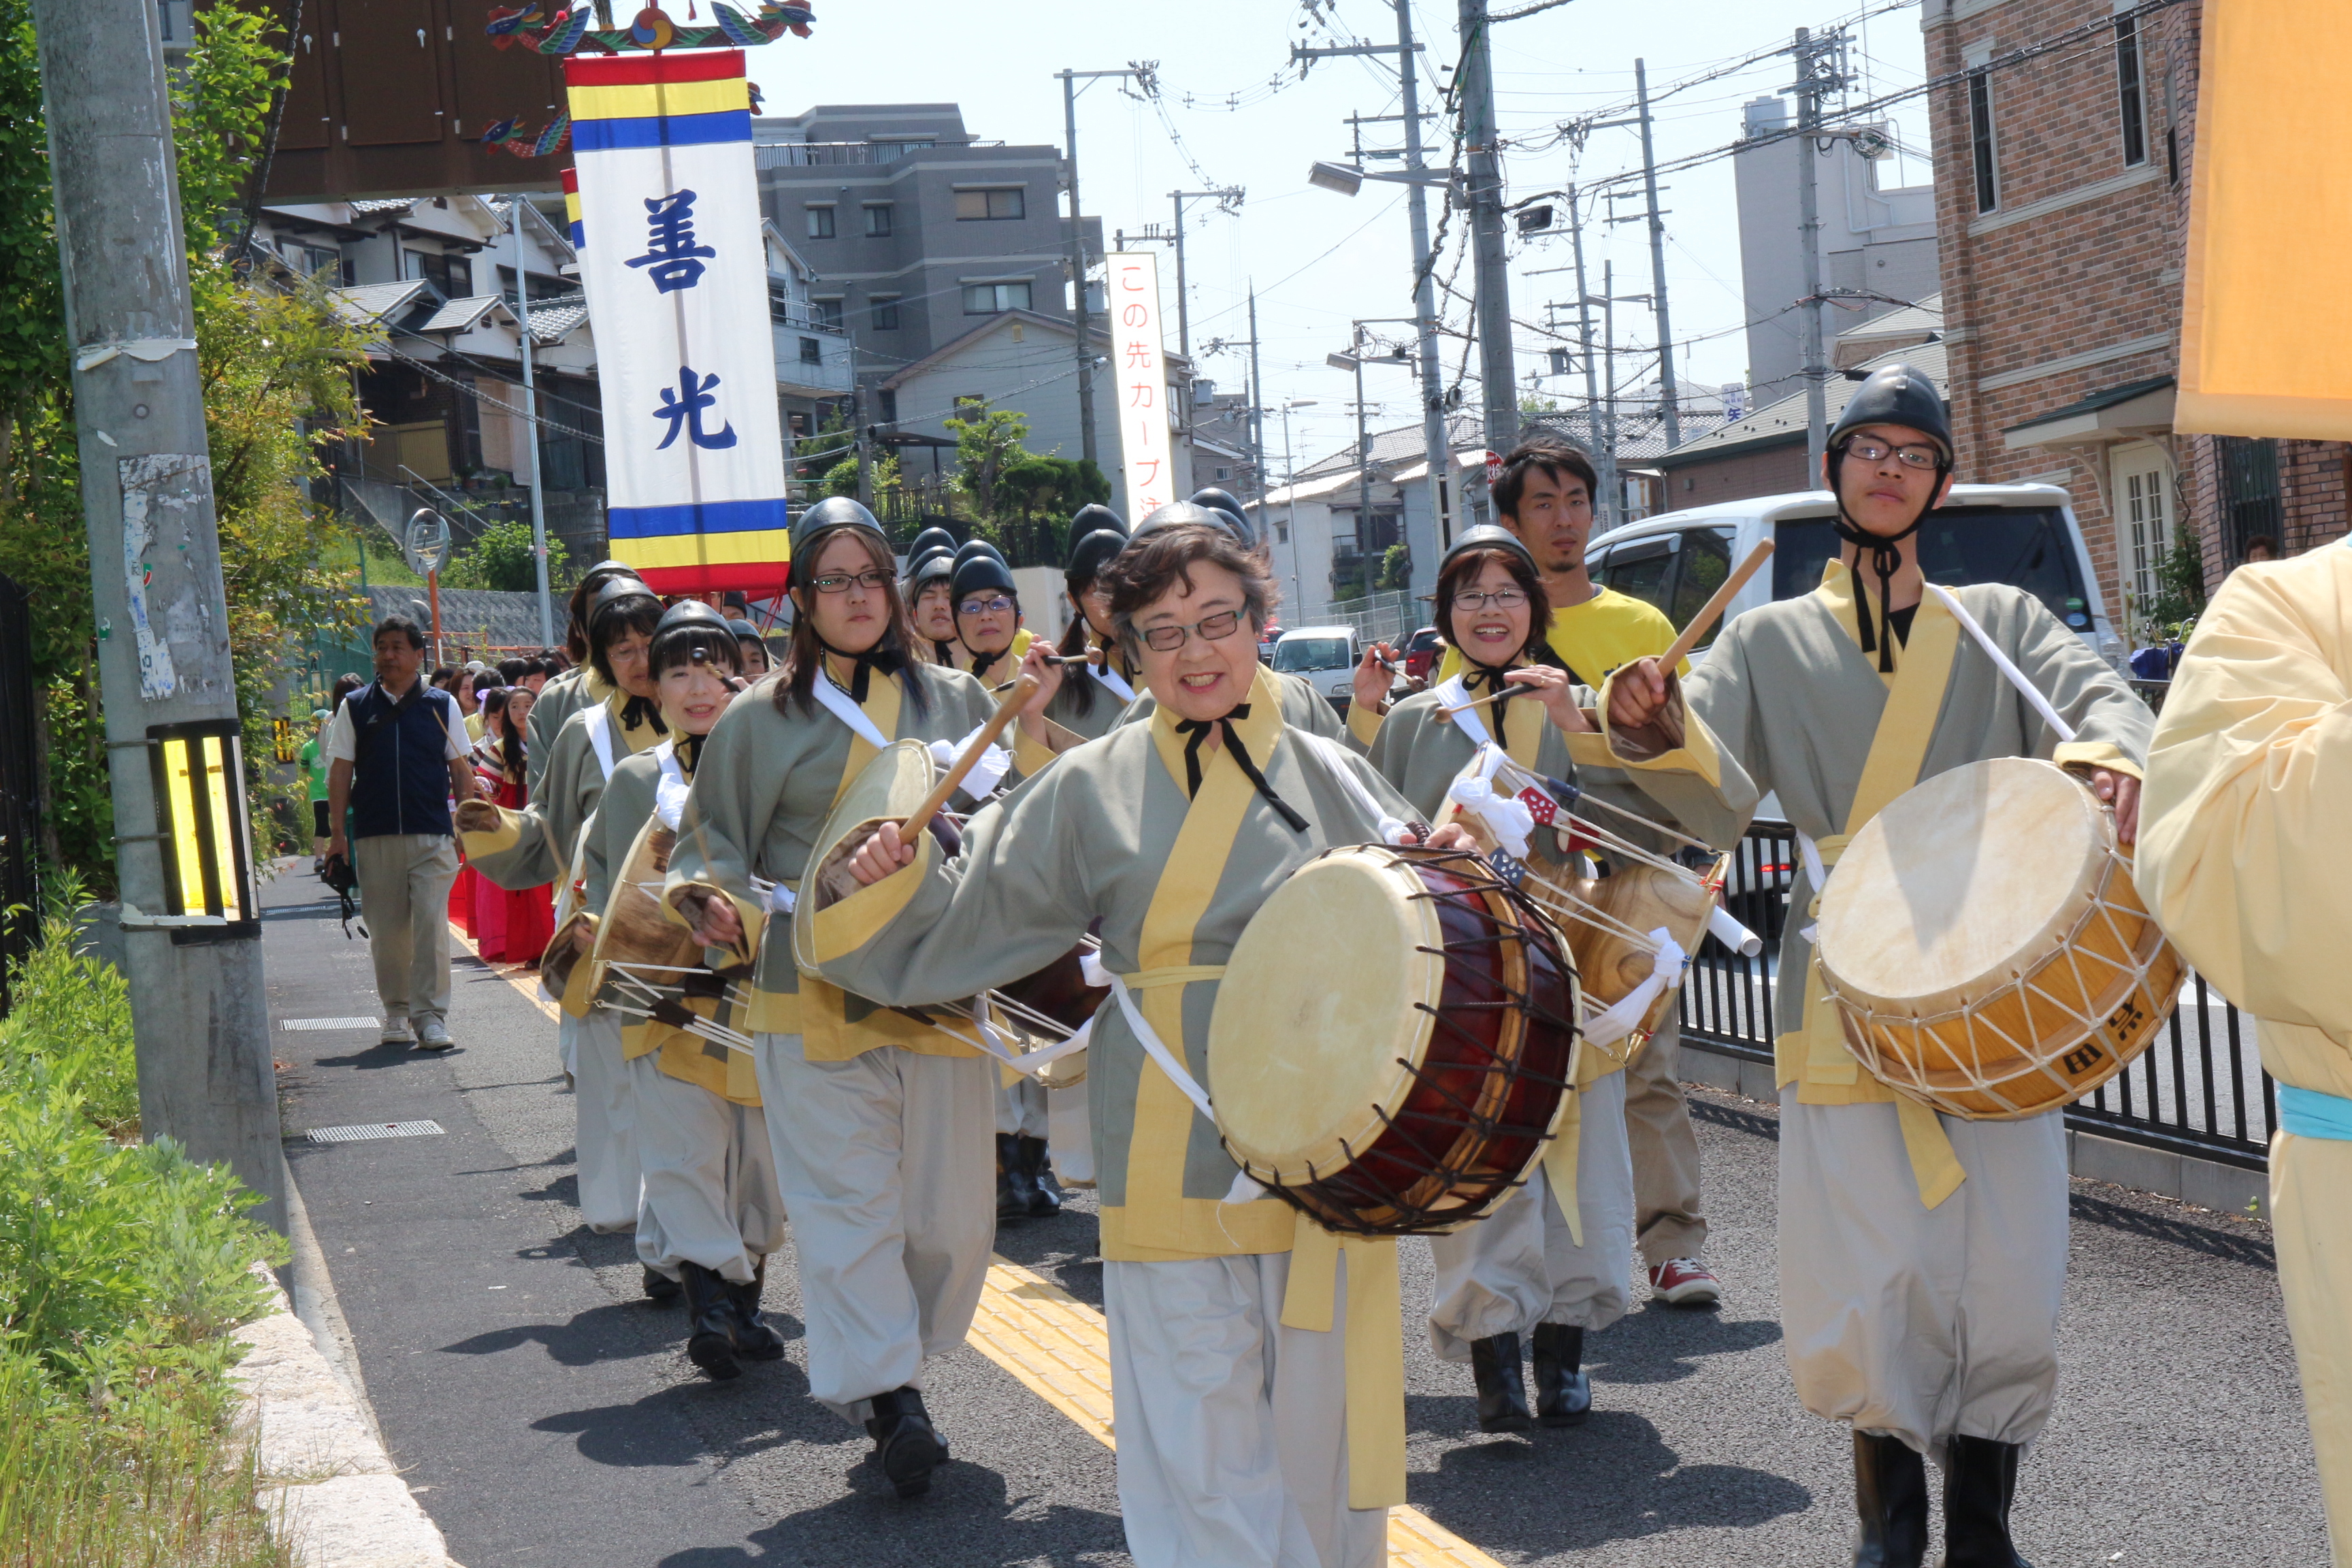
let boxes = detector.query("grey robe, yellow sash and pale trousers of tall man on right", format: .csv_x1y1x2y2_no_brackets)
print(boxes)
1688,562,2152,1455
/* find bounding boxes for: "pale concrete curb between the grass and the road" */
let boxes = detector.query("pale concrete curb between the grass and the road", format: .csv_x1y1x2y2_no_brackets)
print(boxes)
231,1194,461,1568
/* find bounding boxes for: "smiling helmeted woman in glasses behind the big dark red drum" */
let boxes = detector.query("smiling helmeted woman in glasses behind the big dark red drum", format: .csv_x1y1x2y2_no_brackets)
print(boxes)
1371,524,1754,1432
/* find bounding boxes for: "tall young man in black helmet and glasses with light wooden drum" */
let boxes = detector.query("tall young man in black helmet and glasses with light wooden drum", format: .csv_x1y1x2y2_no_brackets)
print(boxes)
1611,364,2152,1568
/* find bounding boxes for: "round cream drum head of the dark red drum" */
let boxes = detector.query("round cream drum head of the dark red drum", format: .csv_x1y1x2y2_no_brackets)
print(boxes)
1209,847,1444,1182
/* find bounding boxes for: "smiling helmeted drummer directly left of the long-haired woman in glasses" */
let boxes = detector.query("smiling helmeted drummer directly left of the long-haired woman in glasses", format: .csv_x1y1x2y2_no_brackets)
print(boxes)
567,600,783,1380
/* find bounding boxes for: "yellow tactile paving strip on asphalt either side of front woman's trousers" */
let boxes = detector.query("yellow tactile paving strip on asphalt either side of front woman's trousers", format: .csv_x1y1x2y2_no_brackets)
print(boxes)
971,1258,1503,1568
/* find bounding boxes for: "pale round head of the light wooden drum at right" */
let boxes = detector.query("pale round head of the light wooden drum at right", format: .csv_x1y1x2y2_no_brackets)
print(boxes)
1818,757,2114,1015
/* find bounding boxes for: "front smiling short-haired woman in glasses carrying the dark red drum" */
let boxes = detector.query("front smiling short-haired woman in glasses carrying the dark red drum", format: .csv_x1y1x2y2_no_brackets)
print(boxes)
795,524,1465,1568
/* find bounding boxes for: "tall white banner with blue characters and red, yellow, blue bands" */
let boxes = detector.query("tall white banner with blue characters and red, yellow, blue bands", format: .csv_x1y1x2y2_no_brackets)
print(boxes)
564,50,788,595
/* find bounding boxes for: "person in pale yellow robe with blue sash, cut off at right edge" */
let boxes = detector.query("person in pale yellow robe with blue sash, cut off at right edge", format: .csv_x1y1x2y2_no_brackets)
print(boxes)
2136,543,2352,1568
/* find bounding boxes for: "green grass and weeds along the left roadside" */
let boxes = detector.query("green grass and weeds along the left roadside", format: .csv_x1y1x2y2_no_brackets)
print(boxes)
0,886,289,1568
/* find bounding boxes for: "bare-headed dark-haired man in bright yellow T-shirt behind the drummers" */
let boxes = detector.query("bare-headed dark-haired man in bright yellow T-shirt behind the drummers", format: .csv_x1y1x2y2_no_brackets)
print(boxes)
1350,435,1722,1307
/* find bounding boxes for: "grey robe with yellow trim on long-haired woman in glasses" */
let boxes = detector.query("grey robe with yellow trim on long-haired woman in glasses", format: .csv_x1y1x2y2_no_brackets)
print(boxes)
664,661,1054,1060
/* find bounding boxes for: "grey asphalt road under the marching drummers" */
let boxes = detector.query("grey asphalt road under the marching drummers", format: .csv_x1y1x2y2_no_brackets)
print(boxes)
263,872,2326,1568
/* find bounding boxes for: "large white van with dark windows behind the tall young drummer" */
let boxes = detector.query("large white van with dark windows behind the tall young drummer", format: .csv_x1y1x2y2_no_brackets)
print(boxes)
1585,485,2124,668
